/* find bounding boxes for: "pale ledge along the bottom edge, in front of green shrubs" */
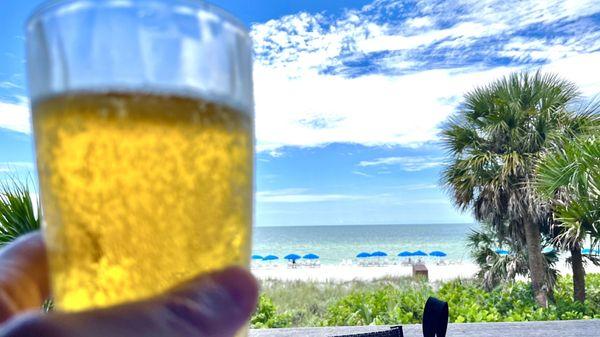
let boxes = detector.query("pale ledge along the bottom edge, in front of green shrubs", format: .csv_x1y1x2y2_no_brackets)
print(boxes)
250,320,600,337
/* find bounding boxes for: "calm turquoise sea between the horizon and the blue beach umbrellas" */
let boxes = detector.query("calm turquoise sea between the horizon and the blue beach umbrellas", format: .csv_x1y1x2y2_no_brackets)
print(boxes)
252,224,474,264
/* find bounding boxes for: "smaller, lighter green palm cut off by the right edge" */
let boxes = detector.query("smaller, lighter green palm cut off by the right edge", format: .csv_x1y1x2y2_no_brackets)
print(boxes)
536,136,600,302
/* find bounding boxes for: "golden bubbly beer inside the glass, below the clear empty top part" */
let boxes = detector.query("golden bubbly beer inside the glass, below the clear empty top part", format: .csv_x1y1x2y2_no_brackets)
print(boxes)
33,92,253,311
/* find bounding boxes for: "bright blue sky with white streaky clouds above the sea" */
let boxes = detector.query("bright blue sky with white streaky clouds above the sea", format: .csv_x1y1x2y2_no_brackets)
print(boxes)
0,0,600,226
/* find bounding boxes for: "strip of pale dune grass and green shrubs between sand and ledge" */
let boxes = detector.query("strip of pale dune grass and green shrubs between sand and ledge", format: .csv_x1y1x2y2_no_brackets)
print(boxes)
252,274,600,328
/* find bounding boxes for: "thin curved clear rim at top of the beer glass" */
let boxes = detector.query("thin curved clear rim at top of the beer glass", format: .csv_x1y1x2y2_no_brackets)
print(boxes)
25,0,250,34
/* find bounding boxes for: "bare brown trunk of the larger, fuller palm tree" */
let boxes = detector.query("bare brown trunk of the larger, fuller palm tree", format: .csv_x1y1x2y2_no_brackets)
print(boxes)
524,221,549,307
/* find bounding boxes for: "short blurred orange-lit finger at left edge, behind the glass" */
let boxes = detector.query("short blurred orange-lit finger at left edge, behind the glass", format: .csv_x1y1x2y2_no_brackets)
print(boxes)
0,232,50,323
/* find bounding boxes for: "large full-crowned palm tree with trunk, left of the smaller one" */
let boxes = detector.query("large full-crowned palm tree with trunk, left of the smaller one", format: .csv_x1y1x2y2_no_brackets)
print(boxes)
442,72,589,306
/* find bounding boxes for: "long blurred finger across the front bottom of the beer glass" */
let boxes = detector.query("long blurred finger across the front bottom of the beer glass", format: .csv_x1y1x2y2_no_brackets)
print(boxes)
0,268,258,337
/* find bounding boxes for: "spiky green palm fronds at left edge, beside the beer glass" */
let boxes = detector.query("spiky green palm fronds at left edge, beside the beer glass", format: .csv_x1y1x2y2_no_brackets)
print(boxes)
0,177,41,247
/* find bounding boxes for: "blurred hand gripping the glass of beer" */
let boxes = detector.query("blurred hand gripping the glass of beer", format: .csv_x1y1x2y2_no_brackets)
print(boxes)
0,233,258,337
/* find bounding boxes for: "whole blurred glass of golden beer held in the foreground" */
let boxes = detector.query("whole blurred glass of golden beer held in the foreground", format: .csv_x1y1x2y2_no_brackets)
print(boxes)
27,0,254,311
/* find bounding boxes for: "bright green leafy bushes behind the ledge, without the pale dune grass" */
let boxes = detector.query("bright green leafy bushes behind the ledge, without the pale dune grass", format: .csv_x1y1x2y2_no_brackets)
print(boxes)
252,274,600,328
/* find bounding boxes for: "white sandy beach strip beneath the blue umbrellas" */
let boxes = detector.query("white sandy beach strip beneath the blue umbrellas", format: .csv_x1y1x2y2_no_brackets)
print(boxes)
252,261,600,282
